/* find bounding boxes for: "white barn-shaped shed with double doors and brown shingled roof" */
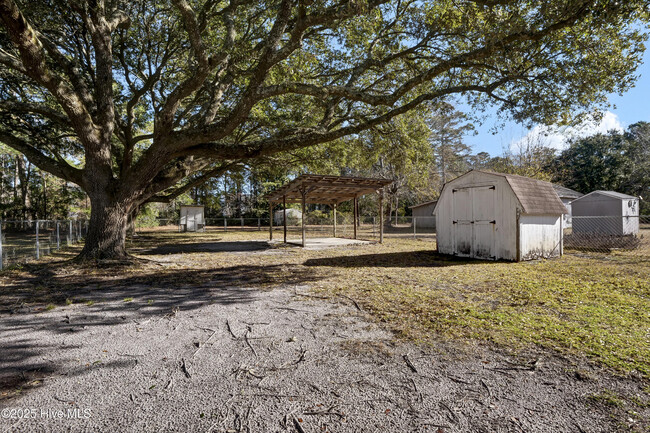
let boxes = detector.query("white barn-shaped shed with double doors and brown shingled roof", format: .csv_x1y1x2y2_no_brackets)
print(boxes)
434,170,567,261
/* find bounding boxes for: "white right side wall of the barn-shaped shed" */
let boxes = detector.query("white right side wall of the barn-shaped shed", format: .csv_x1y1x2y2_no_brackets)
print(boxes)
519,215,562,260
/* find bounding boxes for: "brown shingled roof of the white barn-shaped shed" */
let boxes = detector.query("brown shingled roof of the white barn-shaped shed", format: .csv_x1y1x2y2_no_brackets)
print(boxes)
468,170,568,215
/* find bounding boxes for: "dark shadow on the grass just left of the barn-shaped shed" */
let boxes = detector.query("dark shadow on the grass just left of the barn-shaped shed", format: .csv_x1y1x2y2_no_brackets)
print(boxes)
303,251,499,268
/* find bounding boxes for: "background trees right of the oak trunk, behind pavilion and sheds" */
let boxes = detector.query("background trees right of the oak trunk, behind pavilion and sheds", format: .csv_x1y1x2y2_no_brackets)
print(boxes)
147,111,650,222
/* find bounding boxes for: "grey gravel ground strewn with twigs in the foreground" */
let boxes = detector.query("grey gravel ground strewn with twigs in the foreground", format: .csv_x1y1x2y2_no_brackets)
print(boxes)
0,238,650,433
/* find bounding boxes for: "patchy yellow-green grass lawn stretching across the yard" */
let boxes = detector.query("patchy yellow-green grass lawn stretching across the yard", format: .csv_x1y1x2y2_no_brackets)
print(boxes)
5,231,650,378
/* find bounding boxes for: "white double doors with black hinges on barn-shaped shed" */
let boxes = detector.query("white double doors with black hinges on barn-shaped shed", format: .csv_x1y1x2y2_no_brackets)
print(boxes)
452,185,496,259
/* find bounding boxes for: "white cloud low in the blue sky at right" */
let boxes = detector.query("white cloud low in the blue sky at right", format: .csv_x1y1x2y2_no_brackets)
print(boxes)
510,111,625,151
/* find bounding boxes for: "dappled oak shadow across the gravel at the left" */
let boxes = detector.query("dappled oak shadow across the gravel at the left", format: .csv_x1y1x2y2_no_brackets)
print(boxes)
0,263,318,401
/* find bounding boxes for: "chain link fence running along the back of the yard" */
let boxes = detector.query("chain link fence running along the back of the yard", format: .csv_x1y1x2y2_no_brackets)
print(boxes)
0,213,650,270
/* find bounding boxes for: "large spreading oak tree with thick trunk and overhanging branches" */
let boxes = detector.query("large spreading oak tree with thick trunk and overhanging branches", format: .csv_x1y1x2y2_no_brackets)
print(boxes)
0,0,647,259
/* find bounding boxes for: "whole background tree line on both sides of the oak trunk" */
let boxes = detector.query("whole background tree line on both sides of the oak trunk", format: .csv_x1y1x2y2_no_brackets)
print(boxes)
0,109,650,223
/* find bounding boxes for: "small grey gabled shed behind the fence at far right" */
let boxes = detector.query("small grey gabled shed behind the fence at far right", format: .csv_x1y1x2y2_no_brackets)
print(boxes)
571,191,639,236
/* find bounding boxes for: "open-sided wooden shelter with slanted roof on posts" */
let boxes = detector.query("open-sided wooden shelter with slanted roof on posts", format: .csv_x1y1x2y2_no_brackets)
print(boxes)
266,174,393,247
